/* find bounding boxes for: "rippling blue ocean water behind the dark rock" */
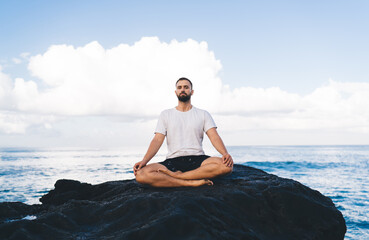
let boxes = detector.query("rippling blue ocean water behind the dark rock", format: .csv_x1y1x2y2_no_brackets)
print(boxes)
0,146,369,240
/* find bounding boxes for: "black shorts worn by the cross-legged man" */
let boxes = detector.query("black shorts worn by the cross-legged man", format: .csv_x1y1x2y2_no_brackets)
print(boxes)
159,155,210,172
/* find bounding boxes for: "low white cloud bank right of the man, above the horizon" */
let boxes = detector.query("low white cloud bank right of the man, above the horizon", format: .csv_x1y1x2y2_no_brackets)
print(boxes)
217,80,369,133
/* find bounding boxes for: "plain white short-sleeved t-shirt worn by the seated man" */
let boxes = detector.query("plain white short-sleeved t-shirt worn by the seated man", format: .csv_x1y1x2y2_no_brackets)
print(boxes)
155,106,216,158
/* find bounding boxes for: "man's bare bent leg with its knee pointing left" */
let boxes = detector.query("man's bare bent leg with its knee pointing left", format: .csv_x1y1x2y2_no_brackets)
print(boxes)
136,163,213,187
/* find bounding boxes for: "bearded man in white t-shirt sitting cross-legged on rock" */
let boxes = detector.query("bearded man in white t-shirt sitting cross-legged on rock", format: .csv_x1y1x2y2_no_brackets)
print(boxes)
133,78,233,187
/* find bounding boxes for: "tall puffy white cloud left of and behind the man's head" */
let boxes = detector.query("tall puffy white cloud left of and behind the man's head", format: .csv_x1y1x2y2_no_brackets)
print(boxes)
21,38,221,117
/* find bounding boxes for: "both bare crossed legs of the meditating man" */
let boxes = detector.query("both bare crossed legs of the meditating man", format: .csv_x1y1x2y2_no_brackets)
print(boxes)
136,157,232,187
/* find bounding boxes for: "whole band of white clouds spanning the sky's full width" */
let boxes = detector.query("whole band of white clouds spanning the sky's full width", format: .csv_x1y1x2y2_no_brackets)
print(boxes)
0,37,369,140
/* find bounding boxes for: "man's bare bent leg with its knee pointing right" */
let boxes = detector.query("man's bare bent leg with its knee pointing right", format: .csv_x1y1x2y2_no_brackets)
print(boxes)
158,157,233,180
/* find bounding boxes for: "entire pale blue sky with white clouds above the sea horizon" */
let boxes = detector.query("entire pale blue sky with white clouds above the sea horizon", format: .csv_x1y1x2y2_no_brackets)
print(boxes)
0,0,369,147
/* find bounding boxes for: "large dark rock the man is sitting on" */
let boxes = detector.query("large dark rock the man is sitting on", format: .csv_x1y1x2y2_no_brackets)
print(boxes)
0,165,346,240
